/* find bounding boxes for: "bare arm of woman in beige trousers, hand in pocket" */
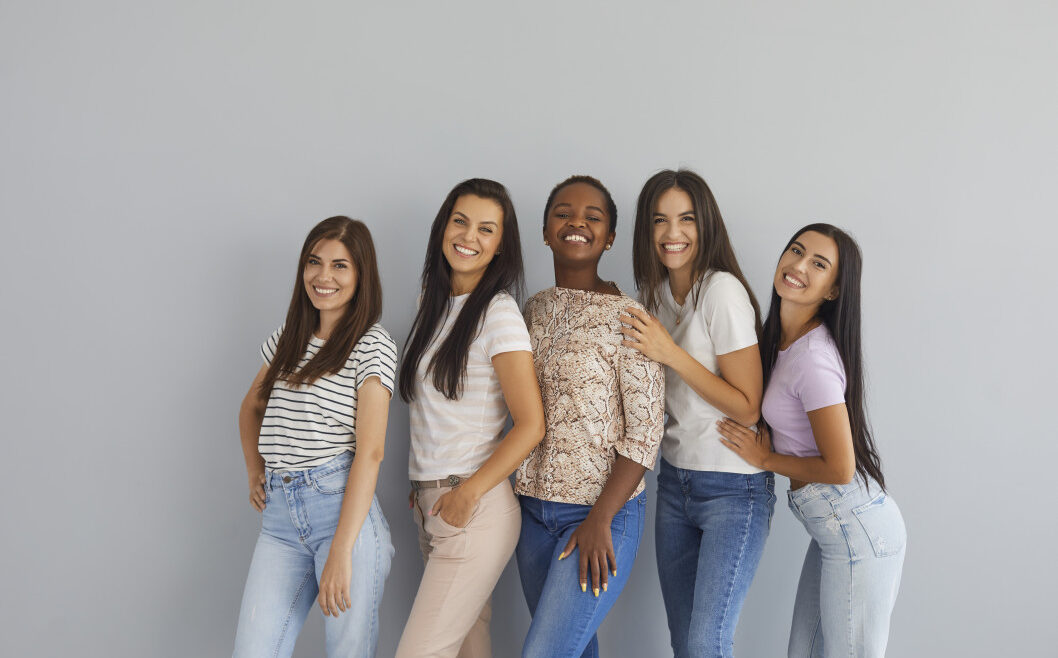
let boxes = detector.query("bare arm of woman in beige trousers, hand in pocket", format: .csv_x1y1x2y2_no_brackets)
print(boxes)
430,351,544,528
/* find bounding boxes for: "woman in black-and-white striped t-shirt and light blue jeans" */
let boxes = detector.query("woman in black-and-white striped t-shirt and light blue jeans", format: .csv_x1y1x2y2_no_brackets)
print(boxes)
235,217,397,657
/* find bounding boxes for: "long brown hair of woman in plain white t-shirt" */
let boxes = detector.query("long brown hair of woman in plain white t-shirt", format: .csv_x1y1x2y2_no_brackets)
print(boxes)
632,169,761,336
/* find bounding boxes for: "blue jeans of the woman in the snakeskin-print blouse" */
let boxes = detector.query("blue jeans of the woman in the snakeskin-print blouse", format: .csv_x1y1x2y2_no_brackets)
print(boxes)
514,492,646,658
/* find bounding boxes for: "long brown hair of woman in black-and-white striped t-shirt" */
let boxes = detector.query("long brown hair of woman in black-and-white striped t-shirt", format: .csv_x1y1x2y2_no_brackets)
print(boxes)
257,216,382,398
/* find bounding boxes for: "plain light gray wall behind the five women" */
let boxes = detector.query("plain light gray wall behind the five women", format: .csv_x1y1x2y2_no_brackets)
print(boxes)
0,0,1058,656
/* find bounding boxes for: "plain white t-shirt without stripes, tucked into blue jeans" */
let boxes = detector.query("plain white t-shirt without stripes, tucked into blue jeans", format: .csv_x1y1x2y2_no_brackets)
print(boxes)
657,271,761,473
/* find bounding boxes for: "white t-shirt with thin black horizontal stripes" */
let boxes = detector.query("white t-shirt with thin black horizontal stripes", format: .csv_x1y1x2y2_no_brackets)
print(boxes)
257,324,397,471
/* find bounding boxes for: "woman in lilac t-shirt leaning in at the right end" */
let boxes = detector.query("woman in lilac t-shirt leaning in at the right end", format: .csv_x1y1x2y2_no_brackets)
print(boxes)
719,224,907,657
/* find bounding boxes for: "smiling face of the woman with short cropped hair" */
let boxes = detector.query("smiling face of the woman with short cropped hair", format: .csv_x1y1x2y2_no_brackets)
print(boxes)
544,183,615,263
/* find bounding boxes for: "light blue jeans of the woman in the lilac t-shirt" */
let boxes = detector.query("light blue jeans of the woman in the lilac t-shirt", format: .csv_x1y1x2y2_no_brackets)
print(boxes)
789,477,907,658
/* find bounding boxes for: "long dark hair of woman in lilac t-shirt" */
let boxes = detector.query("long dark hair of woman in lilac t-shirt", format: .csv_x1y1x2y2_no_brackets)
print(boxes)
761,223,886,491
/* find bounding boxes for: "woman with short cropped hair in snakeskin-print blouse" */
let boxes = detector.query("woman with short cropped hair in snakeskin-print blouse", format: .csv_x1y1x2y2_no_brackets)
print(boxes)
516,176,664,658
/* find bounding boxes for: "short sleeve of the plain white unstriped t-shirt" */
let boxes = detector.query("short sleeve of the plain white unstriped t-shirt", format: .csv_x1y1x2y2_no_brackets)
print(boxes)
700,272,756,355
